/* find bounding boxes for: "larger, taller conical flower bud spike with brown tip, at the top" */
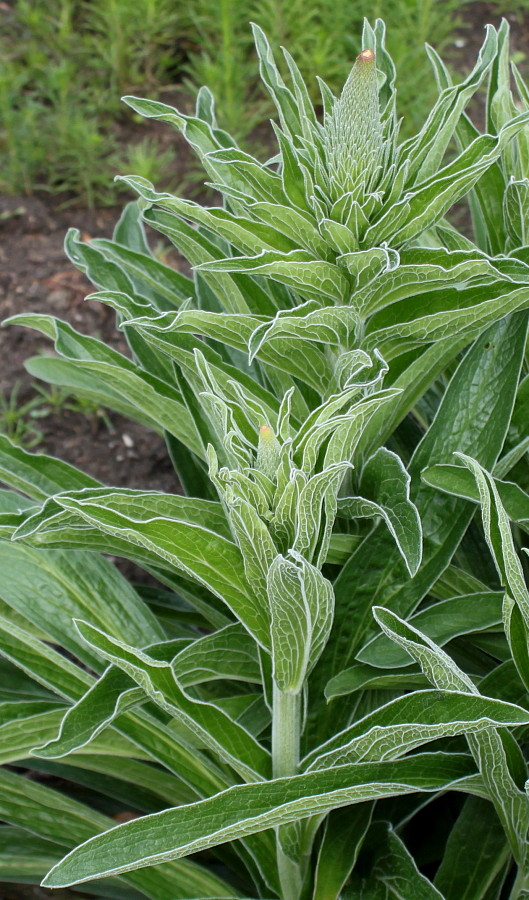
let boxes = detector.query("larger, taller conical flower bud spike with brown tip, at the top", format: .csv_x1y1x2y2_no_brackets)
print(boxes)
325,50,384,200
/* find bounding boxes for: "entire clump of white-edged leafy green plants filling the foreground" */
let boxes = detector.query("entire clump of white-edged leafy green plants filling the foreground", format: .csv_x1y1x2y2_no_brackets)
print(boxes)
0,15,529,900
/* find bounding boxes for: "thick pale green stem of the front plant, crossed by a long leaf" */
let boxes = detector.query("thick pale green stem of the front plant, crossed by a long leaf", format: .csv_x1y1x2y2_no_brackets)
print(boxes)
272,684,303,900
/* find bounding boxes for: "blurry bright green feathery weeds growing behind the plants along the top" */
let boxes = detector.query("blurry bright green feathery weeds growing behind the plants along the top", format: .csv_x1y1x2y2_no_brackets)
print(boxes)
0,0,470,206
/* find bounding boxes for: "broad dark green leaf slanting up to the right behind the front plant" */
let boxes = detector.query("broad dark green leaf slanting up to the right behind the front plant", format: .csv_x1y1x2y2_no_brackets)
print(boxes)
322,315,527,715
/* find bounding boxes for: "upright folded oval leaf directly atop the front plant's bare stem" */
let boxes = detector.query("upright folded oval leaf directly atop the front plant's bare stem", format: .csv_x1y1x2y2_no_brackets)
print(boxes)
267,551,334,694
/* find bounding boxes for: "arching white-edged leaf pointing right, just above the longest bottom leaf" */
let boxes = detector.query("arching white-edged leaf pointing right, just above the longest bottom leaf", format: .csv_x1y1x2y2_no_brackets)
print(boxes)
303,690,529,771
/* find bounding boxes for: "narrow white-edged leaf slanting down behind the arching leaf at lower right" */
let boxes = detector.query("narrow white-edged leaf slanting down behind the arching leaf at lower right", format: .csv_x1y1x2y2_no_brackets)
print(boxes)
373,607,529,860
